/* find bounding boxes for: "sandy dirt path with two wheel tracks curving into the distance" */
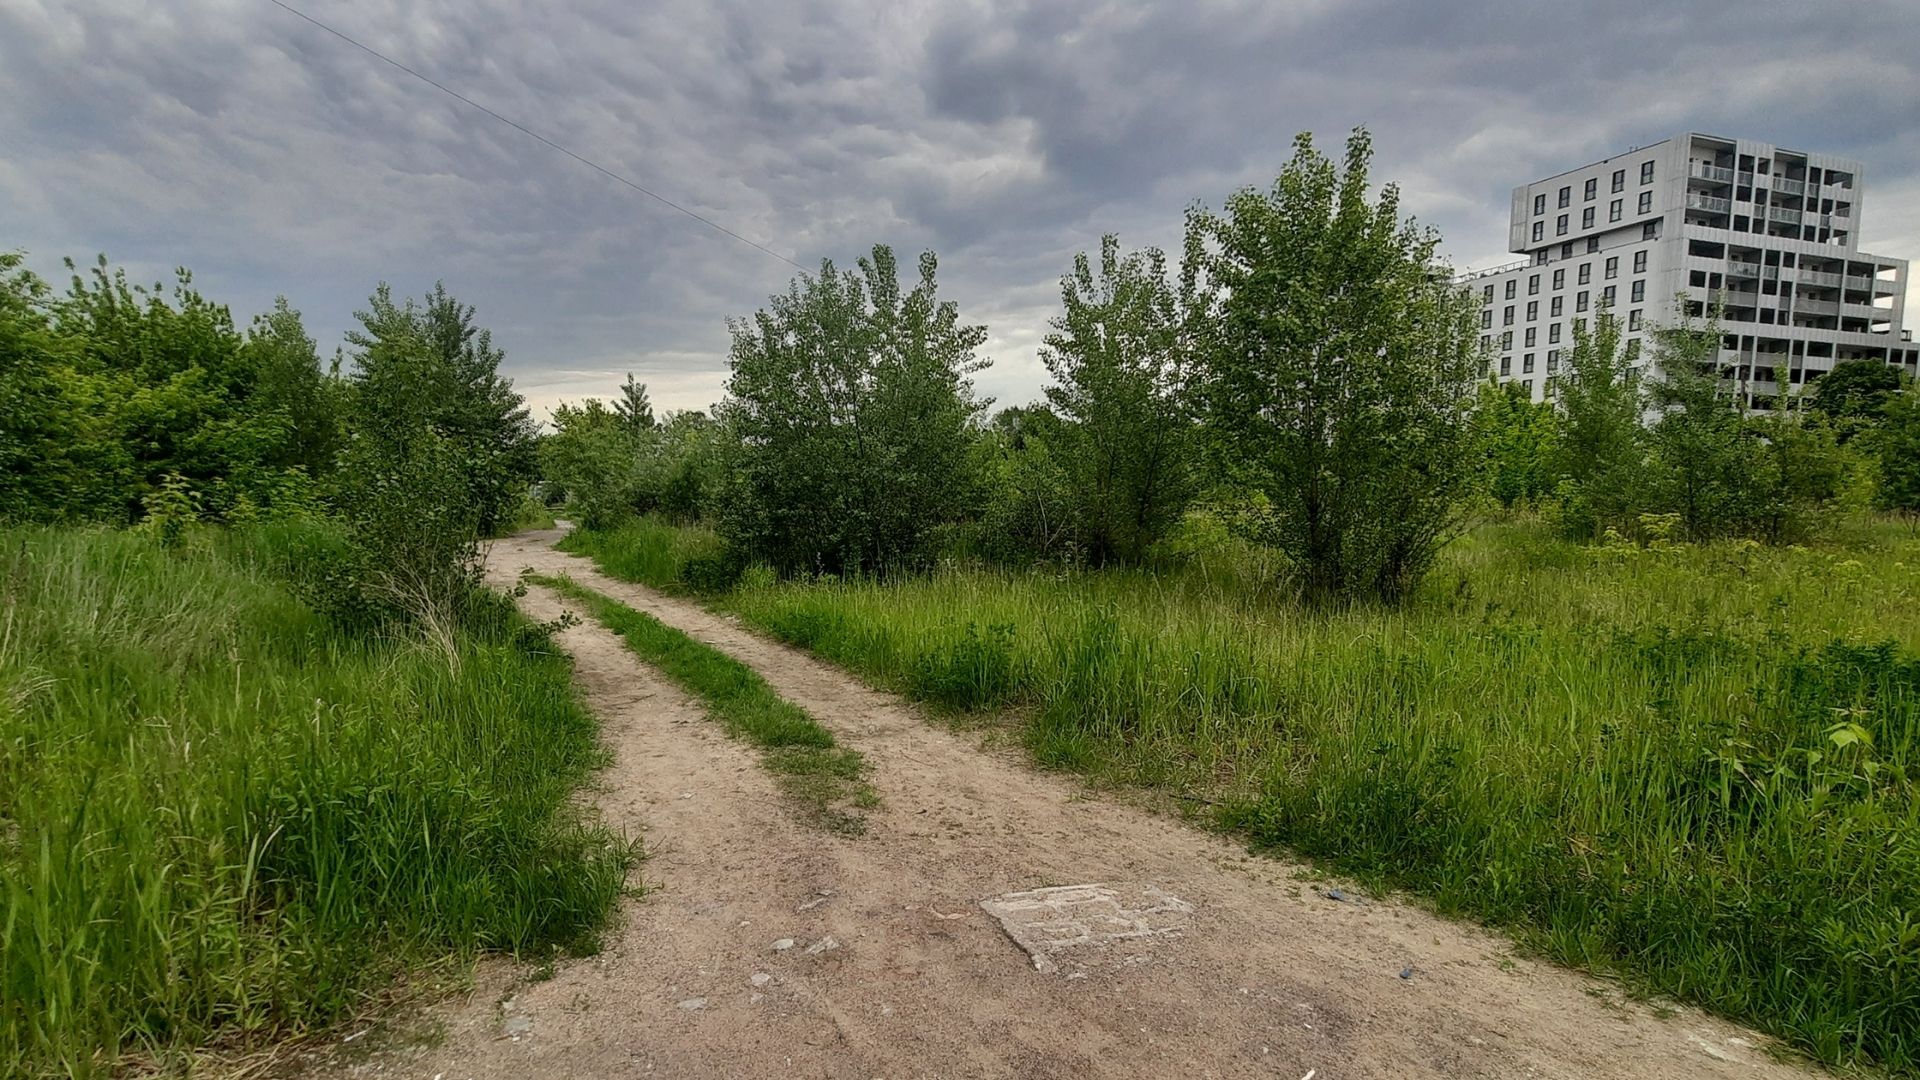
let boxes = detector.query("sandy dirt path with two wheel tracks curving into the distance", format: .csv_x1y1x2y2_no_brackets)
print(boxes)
330,532,1818,1080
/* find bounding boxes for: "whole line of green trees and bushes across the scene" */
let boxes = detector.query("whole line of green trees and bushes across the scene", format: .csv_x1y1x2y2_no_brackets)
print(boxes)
11,131,1920,607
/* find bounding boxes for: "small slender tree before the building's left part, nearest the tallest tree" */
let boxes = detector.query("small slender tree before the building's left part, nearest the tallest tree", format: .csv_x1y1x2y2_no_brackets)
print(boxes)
1553,304,1645,540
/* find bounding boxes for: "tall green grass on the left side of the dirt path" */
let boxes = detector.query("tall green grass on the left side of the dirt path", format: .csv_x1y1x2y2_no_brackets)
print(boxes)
0,527,630,1076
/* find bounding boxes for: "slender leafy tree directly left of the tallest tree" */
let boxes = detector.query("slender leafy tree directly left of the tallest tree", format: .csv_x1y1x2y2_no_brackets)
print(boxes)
1041,234,1196,563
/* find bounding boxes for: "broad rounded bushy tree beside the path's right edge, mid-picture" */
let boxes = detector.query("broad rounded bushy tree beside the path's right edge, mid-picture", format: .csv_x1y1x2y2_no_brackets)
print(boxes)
718,246,987,573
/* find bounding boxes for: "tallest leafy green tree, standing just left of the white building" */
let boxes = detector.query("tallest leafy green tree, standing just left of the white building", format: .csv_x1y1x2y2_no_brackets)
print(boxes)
1187,131,1480,601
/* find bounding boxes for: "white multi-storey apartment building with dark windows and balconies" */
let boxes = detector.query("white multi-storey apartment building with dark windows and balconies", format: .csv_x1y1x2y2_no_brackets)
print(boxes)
1463,133,1920,409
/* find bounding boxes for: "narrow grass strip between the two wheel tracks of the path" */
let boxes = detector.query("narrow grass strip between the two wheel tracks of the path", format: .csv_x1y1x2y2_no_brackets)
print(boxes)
530,577,877,834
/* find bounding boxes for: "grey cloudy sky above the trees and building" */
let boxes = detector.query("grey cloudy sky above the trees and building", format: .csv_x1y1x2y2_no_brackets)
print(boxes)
0,0,1920,417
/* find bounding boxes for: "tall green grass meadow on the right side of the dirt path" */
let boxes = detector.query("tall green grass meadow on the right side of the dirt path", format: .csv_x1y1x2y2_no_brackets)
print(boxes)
572,523,1920,1074
